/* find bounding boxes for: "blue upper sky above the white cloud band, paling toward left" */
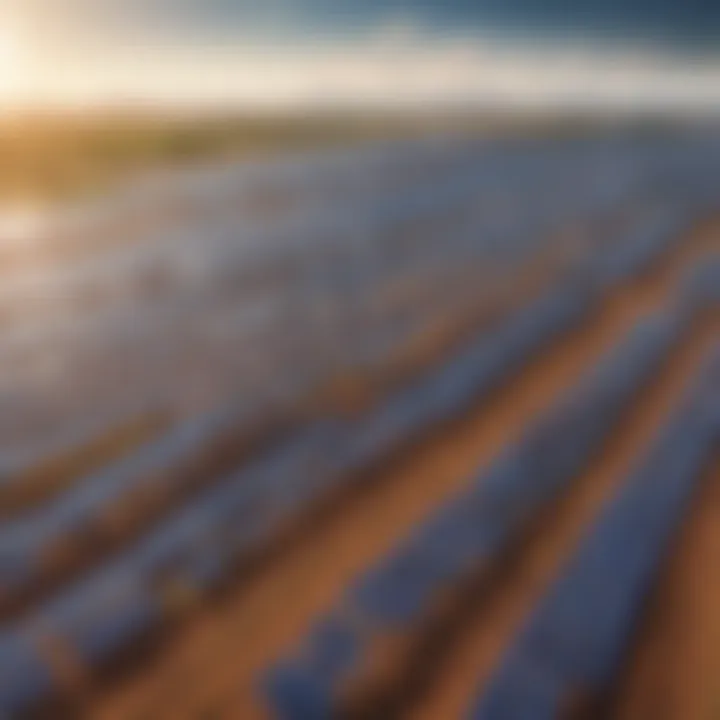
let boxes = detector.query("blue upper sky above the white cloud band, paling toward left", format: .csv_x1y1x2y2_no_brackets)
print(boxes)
15,0,720,50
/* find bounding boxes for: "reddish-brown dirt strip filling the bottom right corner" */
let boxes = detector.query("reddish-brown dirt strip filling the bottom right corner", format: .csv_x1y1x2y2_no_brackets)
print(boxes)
613,457,720,720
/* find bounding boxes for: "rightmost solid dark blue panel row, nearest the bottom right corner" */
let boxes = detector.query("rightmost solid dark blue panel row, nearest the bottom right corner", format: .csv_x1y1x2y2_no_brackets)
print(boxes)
474,352,720,720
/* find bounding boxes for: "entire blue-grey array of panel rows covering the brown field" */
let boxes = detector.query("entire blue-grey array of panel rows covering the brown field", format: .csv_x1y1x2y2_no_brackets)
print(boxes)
0,134,720,720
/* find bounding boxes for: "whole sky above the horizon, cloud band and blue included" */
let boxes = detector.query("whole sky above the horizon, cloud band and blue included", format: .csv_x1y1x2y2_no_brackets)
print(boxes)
0,0,720,112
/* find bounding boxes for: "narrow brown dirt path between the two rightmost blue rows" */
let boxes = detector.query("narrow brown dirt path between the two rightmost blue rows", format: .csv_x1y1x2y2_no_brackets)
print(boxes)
410,322,720,720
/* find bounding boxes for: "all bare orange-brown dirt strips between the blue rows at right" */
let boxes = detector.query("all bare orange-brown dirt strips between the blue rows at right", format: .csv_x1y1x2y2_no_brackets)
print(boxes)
82,225,720,720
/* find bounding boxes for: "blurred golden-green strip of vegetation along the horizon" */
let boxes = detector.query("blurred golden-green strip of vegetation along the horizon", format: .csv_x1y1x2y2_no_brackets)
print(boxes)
0,111,700,201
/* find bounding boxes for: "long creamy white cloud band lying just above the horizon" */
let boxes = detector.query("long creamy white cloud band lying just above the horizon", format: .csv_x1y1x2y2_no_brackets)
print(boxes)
0,10,720,113
